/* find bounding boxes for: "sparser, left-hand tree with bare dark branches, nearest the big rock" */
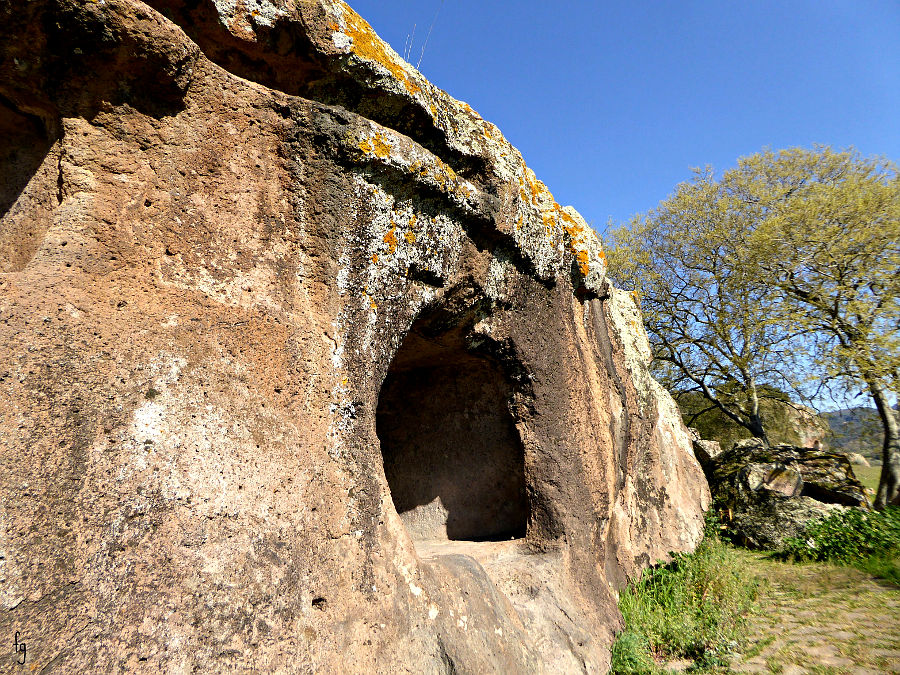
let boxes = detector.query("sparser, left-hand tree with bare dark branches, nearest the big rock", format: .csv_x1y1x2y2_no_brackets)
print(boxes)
608,168,796,444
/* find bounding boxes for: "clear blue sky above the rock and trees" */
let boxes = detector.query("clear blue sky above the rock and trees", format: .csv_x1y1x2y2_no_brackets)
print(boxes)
349,0,900,231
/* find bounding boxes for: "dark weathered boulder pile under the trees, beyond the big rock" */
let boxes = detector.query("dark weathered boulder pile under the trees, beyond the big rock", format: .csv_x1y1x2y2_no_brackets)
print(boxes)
703,439,870,549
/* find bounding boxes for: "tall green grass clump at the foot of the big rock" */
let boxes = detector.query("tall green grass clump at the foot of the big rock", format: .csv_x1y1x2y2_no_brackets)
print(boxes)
612,522,758,673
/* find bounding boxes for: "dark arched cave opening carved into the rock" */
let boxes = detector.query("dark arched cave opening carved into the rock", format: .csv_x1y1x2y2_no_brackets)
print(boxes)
376,318,529,541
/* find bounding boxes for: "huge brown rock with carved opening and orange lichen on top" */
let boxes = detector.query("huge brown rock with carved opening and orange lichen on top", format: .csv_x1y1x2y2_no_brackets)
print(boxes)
0,0,708,673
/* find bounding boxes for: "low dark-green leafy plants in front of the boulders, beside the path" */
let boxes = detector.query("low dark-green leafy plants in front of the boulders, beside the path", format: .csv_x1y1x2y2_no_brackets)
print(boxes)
777,507,900,578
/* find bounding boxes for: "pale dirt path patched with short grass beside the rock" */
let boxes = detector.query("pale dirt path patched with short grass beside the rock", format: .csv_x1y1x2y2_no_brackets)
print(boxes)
731,551,900,675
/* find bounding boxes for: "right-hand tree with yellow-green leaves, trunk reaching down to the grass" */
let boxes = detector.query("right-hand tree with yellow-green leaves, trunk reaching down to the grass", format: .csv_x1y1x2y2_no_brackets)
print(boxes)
740,148,900,508
